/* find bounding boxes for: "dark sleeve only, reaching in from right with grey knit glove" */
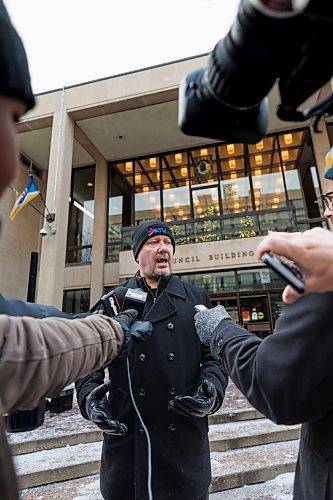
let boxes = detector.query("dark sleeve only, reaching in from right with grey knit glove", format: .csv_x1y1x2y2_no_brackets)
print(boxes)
211,293,333,424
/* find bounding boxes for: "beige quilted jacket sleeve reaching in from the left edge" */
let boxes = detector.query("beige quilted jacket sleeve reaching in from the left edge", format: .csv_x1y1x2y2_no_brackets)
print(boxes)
0,315,124,413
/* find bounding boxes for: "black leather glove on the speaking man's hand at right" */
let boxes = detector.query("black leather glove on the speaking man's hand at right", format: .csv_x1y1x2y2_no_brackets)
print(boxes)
168,378,220,418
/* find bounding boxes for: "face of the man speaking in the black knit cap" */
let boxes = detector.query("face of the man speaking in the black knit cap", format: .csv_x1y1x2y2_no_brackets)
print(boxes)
138,235,173,281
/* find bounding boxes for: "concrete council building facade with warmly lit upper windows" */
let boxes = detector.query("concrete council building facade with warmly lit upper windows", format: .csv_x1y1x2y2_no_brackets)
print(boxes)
0,55,333,336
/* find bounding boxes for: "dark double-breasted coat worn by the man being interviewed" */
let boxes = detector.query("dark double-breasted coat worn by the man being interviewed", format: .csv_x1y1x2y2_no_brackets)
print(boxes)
76,276,227,500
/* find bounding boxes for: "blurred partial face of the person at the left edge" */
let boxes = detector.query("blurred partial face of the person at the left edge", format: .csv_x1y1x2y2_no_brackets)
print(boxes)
0,95,25,196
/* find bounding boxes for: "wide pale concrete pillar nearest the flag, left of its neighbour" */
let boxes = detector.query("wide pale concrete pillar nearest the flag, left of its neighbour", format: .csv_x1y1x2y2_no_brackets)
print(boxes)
37,90,74,309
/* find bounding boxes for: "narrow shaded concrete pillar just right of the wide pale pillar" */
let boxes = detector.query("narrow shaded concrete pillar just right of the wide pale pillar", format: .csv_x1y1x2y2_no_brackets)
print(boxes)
90,158,108,306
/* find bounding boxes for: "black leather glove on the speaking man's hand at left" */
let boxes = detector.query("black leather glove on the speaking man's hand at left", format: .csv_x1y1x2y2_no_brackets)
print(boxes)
85,382,128,436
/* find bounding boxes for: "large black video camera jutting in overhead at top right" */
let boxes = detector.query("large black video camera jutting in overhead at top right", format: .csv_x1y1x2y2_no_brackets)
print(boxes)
178,0,333,144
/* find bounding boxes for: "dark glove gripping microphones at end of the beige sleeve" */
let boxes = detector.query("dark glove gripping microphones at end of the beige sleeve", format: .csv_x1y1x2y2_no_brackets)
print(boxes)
113,309,153,359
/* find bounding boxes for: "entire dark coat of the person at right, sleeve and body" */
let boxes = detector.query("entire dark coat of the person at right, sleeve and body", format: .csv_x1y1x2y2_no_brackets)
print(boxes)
211,293,333,500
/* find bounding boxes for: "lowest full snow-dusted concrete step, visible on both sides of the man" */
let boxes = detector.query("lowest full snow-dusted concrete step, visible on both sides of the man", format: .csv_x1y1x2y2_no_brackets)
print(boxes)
14,440,299,492
